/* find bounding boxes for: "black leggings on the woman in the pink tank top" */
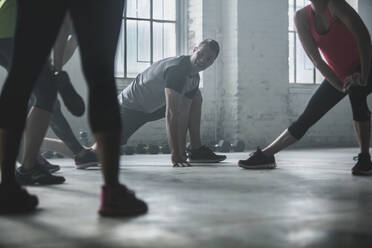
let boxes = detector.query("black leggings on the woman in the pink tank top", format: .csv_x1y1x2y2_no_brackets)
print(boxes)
288,75,372,139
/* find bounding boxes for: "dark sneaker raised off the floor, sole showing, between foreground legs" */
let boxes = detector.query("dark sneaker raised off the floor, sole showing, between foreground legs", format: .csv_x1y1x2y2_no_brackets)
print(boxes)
53,71,85,116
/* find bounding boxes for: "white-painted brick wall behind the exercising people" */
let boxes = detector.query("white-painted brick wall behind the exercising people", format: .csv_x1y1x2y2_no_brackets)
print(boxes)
0,0,372,149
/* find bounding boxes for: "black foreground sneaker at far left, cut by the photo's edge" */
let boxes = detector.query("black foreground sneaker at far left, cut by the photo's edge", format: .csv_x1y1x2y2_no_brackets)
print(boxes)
0,184,39,215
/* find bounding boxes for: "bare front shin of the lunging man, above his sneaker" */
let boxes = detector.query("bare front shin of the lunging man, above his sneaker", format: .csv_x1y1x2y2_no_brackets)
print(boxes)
188,91,203,149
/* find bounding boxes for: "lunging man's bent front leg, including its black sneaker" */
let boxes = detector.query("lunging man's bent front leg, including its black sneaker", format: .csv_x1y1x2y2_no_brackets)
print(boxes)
188,90,226,163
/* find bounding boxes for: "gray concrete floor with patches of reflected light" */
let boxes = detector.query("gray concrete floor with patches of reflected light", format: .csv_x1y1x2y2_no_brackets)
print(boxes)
0,148,372,248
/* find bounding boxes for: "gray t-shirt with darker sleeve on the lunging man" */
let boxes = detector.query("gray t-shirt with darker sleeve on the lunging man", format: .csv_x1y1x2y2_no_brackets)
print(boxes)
118,56,200,113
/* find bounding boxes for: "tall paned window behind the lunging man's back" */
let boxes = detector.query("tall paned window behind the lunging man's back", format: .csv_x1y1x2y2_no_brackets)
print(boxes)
115,0,183,78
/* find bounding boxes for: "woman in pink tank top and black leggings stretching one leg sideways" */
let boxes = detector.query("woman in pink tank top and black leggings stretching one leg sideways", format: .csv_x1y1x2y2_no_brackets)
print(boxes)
238,0,372,175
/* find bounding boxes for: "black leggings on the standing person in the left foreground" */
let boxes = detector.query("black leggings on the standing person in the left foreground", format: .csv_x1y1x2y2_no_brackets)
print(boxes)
0,0,124,134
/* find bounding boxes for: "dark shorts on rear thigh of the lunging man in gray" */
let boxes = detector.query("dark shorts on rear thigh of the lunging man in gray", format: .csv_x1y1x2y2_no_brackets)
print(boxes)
120,107,165,145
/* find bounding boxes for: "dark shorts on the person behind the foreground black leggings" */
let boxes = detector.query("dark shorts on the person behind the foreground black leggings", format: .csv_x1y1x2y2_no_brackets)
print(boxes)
0,38,57,112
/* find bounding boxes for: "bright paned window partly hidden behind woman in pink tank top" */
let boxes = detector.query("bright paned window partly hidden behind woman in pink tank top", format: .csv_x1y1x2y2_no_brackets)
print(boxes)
288,0,358,84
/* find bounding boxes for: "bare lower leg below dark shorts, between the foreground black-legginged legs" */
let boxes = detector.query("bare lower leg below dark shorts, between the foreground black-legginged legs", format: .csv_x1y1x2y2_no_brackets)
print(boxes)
22,107,52,170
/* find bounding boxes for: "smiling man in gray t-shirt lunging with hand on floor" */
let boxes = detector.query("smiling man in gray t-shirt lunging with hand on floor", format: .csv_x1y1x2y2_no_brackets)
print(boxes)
118,39,226,167
